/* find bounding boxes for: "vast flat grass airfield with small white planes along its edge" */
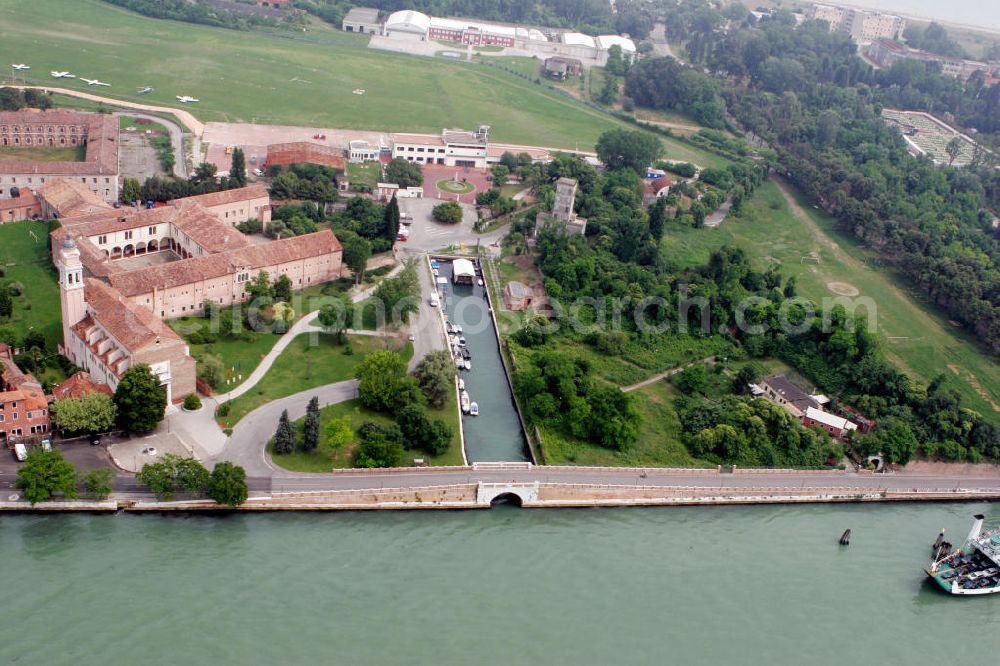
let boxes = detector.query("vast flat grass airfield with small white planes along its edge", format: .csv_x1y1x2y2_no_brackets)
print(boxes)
0,0,720,161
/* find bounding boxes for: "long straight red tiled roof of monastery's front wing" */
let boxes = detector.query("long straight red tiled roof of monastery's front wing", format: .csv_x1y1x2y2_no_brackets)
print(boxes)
108,229,341,296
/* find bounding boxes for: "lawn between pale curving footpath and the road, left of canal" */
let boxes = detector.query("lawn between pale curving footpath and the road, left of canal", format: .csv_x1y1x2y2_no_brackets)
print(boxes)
220,333,413,428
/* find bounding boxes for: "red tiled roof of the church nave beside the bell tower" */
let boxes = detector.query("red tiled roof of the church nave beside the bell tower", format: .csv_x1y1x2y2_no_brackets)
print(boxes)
84,278,181,352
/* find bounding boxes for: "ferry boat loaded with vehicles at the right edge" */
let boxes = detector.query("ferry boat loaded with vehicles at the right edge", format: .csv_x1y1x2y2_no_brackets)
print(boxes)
926,514,1000,595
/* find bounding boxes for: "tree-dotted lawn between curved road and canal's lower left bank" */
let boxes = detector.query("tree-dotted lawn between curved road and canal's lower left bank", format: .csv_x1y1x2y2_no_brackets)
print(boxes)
268,396,463,472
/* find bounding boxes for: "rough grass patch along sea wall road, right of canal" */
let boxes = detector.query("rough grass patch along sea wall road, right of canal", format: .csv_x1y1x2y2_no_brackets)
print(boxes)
542,382,708,467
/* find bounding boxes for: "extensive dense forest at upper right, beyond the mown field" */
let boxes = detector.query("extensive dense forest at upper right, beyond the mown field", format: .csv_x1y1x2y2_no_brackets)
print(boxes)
644,7,1000,351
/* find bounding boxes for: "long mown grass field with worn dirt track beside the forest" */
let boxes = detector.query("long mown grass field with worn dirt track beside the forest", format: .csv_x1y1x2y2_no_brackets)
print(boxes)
662,182,1000,423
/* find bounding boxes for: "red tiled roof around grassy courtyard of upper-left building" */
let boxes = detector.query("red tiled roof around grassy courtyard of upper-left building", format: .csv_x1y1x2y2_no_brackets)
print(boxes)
0,111,118,176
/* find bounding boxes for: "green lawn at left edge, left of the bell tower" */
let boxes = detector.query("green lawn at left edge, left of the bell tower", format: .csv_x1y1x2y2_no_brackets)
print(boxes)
0,222,62,348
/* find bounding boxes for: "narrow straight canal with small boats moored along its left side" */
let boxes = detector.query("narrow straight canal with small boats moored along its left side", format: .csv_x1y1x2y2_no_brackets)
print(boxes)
437,261,530,463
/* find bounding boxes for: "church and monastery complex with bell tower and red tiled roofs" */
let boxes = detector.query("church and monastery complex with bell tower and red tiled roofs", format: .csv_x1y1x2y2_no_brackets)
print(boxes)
50,179,342,403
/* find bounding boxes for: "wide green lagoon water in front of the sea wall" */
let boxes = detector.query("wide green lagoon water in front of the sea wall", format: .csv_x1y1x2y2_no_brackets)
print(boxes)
0,504,1000,666
